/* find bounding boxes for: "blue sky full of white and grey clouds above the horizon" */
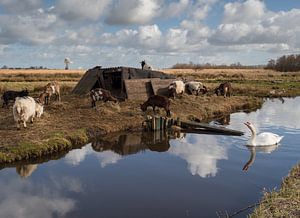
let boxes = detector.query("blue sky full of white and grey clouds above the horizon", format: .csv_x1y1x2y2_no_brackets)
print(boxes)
0,0,300,69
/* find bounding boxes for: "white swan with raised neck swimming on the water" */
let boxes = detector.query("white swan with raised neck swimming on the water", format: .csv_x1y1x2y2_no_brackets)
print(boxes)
244,122,283,146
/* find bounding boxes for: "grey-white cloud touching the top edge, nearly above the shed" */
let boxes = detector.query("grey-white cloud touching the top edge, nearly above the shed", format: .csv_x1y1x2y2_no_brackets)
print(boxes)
106,0,160,24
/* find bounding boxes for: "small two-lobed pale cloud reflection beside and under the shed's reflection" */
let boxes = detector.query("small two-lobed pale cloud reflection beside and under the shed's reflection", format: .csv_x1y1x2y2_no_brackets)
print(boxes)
65,144,122,167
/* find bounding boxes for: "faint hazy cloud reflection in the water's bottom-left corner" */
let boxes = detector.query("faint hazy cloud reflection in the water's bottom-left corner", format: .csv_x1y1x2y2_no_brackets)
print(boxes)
0,178,75,218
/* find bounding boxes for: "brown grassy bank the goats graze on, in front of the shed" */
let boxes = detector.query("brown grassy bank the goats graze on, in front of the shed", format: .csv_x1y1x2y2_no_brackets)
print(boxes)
0,95,263,163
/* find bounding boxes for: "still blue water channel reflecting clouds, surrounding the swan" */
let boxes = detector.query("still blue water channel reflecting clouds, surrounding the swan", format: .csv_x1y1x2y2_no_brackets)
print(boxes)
0,97,300,218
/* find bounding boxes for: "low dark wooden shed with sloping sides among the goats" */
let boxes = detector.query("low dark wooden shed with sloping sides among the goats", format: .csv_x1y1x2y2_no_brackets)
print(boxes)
73,66,175,100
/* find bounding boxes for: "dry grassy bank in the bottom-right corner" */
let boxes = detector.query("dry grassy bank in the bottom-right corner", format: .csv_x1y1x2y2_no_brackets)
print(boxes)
250,163,300,218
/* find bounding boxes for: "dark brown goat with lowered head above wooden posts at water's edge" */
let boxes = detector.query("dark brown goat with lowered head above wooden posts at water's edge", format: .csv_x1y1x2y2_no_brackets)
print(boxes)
140,95,171,116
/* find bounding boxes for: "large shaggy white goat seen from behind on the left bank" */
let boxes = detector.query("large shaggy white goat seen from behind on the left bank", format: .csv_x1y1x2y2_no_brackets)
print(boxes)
13,97,44,129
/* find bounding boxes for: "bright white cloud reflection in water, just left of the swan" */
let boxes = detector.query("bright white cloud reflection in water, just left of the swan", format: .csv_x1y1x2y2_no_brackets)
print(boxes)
169,134,228,177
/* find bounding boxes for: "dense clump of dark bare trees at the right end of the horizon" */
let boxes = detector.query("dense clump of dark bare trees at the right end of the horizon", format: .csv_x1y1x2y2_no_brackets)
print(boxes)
265,54,300,72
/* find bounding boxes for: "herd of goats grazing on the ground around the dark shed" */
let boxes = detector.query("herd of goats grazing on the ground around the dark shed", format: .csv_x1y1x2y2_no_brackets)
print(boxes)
2,80,232,129
